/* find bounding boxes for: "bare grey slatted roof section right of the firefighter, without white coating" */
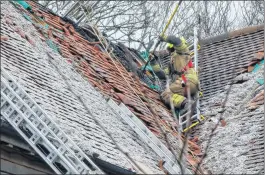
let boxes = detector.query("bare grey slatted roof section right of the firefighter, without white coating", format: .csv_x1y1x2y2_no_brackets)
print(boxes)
198,25,264,100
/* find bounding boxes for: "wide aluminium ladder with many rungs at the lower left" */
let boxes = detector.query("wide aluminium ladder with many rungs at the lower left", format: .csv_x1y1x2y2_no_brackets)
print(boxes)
0,68,103,174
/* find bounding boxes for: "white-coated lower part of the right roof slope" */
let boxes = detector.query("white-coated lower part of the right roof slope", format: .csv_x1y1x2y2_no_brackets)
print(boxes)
197,65,264,174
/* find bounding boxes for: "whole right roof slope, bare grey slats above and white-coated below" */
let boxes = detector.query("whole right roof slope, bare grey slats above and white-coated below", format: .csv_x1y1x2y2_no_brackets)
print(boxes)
194,27,264,174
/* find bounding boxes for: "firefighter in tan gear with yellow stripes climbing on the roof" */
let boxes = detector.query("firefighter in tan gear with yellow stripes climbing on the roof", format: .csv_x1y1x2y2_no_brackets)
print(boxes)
150,35,199,114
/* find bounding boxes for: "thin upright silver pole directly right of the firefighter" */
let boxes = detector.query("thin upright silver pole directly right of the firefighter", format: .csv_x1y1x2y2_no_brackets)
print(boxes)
194,26,200,120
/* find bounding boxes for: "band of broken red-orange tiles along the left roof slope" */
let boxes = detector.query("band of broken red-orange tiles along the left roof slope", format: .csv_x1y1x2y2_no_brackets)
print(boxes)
11,1,203,172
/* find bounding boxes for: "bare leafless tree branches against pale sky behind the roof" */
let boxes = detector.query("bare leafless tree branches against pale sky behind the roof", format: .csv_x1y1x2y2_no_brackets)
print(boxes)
39,1,264,50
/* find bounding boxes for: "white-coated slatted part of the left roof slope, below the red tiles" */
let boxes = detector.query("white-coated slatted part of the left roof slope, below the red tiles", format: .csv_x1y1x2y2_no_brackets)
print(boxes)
1,1,162,174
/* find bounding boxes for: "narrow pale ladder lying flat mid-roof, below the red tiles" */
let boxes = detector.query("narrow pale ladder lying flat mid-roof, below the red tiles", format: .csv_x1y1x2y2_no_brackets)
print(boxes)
107,99,192,174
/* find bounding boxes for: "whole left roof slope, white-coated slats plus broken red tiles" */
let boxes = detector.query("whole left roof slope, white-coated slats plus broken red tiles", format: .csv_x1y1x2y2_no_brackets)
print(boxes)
1,1,203,173
